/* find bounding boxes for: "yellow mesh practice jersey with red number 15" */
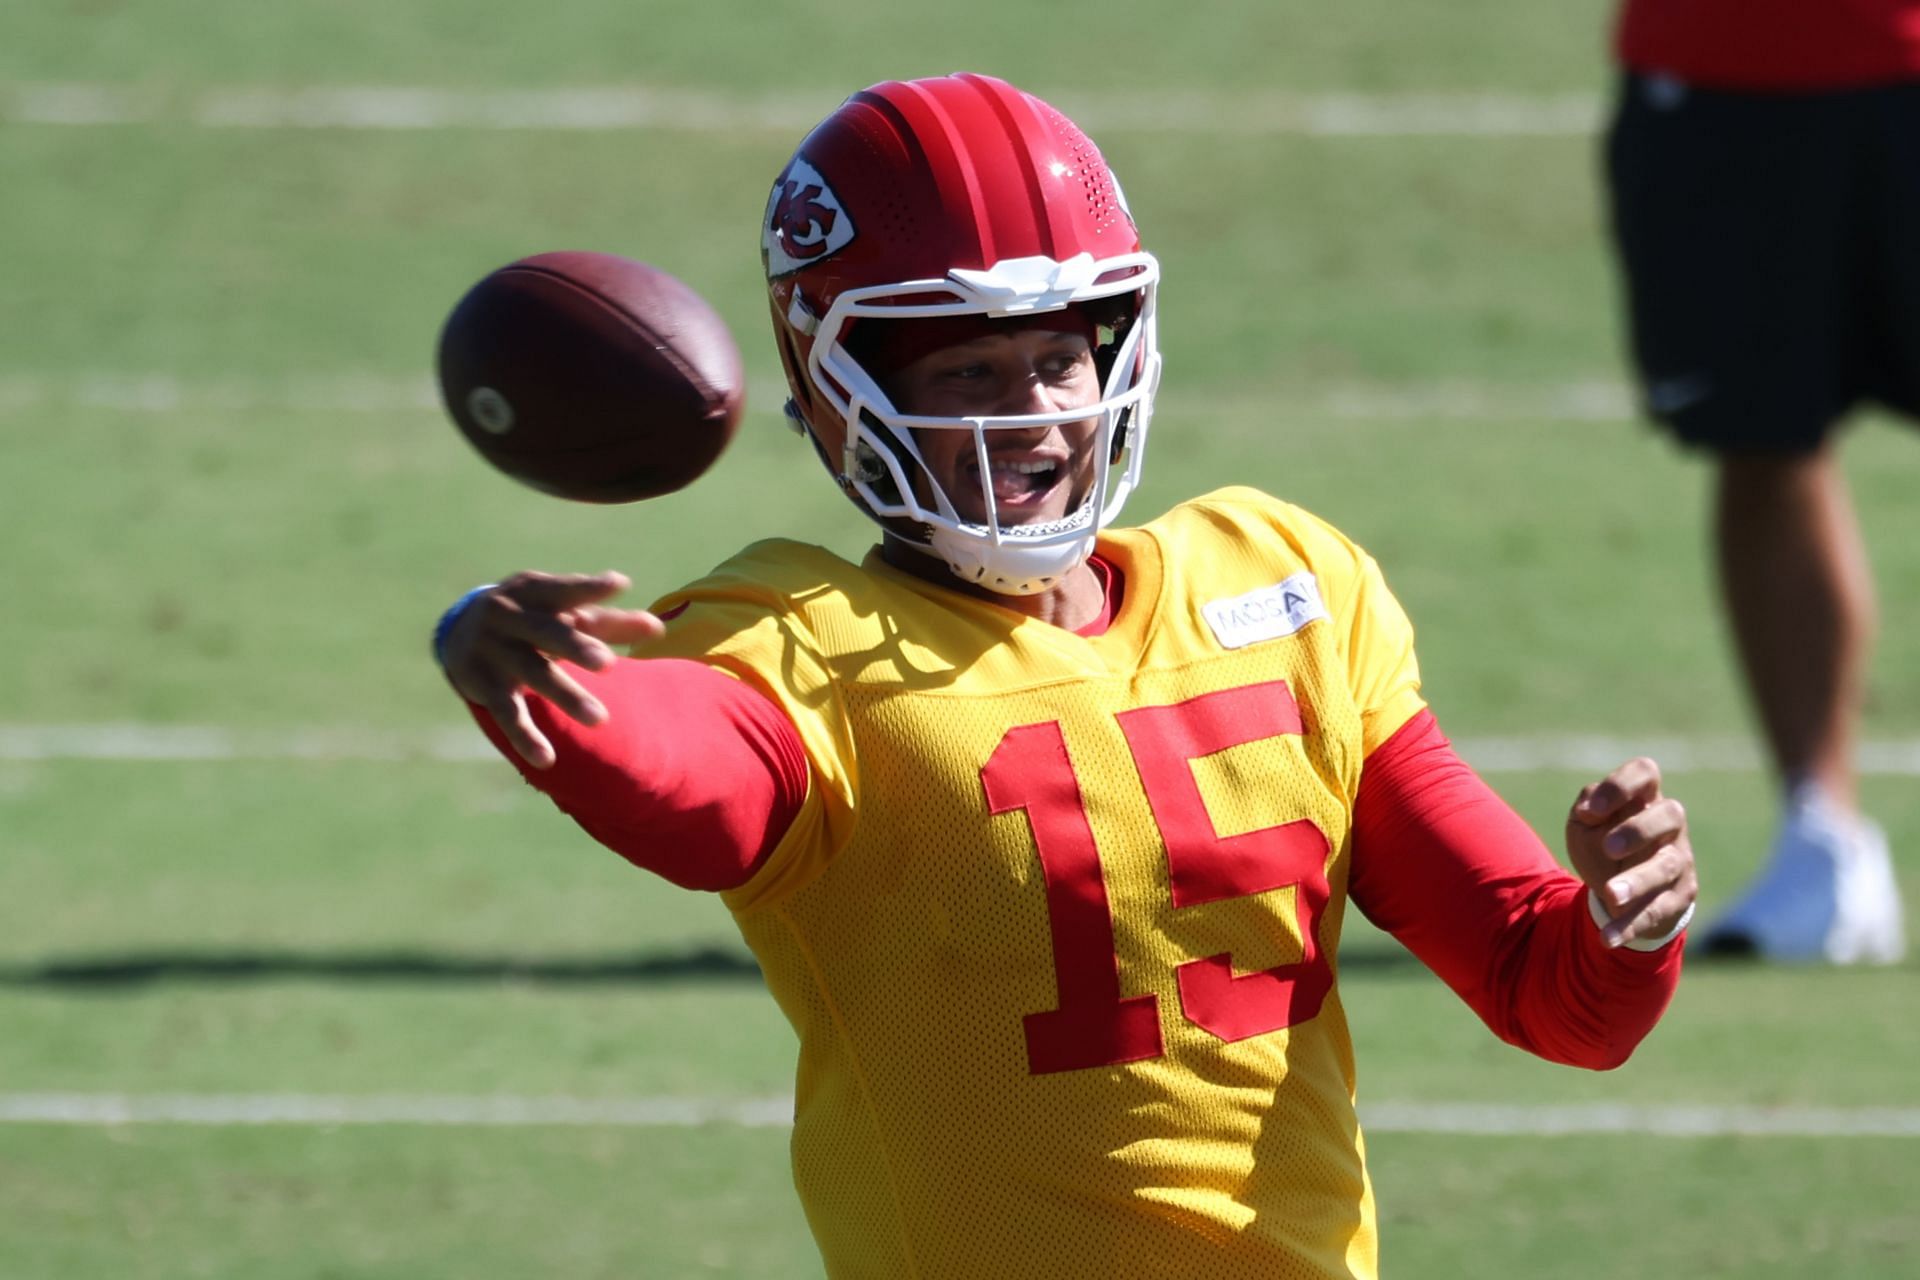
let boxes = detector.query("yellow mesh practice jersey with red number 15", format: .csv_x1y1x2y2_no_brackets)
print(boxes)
647,489,1421,1280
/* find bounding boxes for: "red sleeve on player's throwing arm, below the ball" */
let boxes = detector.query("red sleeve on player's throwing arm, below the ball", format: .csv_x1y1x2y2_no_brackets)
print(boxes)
468,658,806,890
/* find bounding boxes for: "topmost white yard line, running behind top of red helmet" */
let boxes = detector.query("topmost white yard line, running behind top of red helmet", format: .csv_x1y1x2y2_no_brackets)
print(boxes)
0,84,1603,138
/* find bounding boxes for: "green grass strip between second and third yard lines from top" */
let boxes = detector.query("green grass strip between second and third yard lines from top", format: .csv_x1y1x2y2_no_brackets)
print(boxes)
15,401,1920,735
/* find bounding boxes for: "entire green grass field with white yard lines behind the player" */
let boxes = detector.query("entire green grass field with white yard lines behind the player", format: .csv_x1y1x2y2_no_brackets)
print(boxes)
0,0,1920,1280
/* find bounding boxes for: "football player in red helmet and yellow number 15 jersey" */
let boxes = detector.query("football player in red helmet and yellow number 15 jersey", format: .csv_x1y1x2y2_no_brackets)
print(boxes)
436,75,1695,1280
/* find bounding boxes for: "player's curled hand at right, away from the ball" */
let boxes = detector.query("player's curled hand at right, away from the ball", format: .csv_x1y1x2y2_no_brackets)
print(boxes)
1567,756,1699,946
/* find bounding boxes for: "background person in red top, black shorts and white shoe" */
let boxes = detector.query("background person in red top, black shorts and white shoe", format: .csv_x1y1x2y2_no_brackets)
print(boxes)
1607,0,1920,963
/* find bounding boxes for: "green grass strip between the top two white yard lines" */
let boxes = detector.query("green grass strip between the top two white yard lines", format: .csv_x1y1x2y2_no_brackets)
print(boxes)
0,125,1613,385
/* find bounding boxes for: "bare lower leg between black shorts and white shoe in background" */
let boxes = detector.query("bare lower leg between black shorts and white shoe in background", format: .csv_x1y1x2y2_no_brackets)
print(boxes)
1715,441,1876,810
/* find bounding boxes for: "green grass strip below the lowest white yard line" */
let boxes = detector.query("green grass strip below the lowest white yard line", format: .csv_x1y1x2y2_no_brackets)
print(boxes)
0,1128,1920,1280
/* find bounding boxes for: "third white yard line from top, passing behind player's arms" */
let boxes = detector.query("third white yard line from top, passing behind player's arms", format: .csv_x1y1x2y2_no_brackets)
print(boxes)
0,723,1920,777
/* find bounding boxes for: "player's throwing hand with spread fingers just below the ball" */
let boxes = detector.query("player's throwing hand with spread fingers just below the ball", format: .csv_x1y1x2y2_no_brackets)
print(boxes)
442,572,666,770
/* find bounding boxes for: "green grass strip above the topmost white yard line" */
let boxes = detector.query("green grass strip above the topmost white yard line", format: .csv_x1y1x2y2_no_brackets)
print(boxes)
0,0,1607,91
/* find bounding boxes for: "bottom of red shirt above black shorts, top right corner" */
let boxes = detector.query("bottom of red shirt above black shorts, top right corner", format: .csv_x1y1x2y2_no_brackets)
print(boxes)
1615,0,1920,90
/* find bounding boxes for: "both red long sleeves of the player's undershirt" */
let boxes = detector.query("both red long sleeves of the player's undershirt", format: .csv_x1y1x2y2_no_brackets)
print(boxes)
472,658,1680,1069
